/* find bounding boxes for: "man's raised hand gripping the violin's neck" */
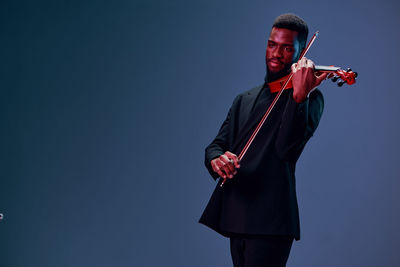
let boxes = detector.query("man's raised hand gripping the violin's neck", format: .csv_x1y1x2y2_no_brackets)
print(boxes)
292,57,328,103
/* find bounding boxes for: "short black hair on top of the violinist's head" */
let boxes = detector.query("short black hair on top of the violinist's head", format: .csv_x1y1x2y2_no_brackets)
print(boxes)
272,13,308,51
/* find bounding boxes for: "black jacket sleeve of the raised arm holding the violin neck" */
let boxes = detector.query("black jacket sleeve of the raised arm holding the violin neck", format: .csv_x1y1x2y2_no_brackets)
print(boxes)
275,89,324,160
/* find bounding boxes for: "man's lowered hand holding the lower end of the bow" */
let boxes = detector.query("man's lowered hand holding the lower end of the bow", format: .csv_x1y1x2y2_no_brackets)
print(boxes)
211,151,240,179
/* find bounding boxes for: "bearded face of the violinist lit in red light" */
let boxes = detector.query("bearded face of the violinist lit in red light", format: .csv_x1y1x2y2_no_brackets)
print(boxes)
265,27,300,76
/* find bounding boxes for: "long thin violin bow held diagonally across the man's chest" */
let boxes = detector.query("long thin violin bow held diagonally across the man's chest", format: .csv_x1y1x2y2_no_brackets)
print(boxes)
220,31,319,187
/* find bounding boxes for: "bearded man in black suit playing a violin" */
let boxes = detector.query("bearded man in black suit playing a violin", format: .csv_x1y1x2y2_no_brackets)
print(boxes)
200,14,327,267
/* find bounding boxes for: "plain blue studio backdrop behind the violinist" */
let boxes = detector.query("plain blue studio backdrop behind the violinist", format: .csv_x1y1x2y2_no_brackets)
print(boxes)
0,0,400,267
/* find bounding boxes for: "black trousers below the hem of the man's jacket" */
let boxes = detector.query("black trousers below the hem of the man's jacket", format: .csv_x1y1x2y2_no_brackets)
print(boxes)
230,235,293,267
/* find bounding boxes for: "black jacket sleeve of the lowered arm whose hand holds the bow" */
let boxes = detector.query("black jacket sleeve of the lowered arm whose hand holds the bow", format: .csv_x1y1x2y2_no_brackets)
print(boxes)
204,96,239,180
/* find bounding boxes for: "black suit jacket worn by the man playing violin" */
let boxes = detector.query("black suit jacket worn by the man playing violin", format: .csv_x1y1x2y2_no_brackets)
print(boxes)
199,85,324,240
